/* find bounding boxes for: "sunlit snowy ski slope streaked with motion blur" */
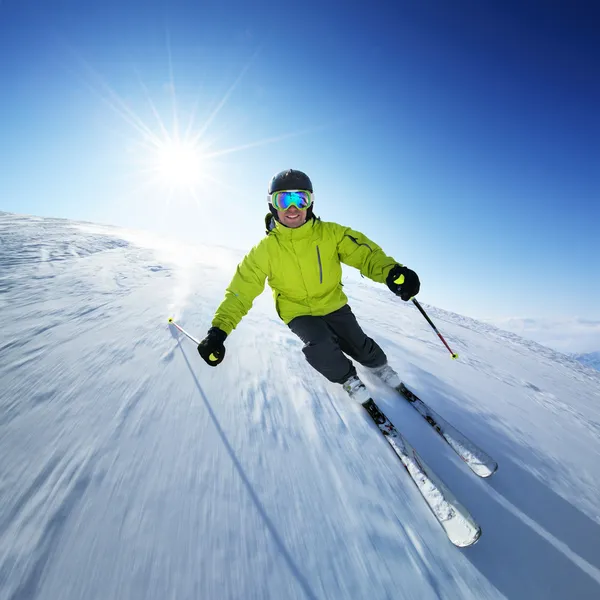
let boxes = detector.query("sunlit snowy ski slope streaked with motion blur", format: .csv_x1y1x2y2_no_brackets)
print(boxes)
0,213,600,600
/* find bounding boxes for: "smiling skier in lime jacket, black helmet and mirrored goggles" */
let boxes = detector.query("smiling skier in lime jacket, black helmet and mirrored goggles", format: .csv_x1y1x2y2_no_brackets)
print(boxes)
198,169,420,404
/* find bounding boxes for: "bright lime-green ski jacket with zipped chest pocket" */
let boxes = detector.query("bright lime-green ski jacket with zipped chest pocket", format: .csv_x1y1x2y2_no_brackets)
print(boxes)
212,219,400,335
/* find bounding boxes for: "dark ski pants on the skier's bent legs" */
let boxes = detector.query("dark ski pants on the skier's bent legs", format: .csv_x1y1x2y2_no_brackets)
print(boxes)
288,304,387,383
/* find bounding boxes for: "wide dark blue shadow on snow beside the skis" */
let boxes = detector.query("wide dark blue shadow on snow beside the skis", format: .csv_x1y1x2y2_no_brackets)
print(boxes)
400,365,600,600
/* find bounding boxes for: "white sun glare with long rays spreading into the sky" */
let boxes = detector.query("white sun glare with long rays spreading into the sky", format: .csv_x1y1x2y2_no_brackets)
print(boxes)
81,47,315,206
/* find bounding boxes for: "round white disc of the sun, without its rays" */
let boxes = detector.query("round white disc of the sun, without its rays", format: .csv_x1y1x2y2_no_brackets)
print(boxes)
153,139,203,187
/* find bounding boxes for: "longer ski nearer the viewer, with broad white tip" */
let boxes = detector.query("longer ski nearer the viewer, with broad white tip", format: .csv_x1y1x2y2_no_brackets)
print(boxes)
363,399,481,548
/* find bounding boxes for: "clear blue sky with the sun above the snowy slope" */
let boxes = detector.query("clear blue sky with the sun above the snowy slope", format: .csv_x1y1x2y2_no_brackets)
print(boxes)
0,0,600,332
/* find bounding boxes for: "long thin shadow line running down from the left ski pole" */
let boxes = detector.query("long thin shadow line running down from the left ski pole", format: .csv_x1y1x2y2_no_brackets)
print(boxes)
170,327,317,600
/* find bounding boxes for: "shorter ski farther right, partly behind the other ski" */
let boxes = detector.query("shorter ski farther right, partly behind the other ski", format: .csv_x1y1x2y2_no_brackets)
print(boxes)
394,383,498,477
